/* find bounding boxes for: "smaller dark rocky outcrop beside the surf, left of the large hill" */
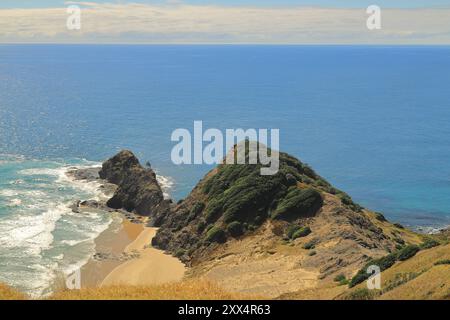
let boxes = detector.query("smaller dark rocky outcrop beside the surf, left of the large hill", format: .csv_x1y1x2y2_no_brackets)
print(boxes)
99,150,167,220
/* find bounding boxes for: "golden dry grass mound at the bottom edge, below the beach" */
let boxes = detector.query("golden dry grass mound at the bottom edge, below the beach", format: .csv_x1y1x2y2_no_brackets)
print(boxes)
50,280,258,300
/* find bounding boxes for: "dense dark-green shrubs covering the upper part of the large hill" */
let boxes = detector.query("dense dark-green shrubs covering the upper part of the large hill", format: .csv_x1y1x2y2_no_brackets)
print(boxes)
199,142,332,241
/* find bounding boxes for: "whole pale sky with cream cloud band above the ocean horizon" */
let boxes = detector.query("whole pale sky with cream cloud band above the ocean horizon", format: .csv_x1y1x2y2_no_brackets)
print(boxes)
0,0,450,45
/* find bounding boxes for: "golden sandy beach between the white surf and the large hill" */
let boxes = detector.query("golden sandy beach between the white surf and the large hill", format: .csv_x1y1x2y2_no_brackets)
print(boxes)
81,214,186,288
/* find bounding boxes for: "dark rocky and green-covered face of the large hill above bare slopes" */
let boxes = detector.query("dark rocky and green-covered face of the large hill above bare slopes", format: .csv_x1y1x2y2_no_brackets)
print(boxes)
153,142,362,262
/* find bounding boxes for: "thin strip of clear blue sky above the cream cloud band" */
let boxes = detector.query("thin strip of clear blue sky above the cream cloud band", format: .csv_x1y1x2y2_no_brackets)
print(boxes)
0,0,450,8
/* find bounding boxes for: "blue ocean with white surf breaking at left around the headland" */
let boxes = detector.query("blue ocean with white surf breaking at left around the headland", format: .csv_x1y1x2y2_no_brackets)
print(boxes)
0,45,450,296
